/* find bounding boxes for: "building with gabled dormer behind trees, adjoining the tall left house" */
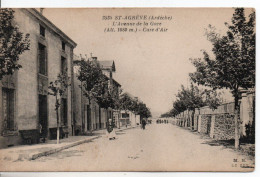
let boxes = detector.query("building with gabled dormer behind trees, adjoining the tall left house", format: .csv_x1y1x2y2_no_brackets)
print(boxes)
73,55,121,135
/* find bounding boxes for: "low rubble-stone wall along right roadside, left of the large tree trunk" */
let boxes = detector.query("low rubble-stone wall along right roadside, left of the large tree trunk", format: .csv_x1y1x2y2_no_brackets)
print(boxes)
177,103,238,140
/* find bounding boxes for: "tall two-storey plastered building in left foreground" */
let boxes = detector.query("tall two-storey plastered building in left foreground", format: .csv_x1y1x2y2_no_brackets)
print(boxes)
0,9,76,147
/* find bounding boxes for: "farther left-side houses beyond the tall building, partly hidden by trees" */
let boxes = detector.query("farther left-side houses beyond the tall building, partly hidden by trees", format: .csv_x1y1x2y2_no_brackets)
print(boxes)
73,55,140,135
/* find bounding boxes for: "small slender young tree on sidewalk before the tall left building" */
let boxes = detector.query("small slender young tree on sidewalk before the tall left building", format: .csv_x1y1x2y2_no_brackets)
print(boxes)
48,72,70,144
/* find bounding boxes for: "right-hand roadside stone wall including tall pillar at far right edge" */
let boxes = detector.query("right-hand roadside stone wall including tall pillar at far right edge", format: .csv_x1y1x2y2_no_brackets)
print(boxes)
174,90,255,140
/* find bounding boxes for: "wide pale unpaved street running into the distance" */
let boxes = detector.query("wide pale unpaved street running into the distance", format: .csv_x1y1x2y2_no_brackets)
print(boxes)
1,124,253,171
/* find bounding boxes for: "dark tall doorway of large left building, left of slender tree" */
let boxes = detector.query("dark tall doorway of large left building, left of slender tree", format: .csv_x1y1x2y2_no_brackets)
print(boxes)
39,95,48,138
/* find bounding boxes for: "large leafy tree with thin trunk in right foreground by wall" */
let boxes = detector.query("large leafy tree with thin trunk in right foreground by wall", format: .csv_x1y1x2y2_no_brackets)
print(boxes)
190,8,255,148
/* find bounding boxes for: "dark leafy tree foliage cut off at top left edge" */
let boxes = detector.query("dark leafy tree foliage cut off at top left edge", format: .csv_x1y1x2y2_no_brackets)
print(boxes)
0,9,30,80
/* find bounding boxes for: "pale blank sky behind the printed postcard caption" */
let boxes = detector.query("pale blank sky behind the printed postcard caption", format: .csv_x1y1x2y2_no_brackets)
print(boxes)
43,8,251,116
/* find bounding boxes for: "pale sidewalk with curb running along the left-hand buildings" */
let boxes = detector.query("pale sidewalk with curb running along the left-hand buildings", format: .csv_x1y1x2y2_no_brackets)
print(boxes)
0,127,134,161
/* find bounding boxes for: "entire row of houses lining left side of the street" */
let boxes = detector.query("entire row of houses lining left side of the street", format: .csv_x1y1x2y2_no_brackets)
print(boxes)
0,9,140,148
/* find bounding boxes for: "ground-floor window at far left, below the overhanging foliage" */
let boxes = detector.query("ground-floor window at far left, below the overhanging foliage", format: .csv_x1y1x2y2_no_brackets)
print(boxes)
2,88,14,130
